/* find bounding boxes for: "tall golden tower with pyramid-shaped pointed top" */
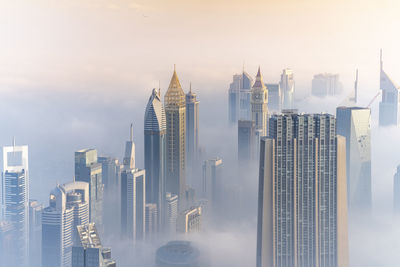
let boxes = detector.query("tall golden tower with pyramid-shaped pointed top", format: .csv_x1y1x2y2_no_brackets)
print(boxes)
164,69,186,206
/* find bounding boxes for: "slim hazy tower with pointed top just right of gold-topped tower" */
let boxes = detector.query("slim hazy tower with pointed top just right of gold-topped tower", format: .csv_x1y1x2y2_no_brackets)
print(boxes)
186,84,199,169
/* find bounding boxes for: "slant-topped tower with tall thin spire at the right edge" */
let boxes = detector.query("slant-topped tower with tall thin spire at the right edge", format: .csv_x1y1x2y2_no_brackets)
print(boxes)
379,49,400,126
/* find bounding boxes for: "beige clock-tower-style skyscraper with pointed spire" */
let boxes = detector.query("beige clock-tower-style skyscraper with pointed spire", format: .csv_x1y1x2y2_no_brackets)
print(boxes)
251,68,268,137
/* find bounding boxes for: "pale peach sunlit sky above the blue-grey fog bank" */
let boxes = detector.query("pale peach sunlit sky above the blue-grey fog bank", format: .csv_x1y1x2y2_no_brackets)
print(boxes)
0,0,400,99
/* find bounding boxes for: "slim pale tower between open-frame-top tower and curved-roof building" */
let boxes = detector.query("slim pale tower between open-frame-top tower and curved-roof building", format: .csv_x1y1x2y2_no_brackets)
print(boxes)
29,200,43,267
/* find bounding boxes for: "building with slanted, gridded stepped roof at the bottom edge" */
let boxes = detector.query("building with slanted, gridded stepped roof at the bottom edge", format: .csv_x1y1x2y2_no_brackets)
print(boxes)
72,223,117,267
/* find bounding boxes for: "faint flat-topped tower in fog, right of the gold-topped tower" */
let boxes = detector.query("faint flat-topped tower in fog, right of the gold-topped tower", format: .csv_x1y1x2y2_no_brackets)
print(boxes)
200,158,222,208
